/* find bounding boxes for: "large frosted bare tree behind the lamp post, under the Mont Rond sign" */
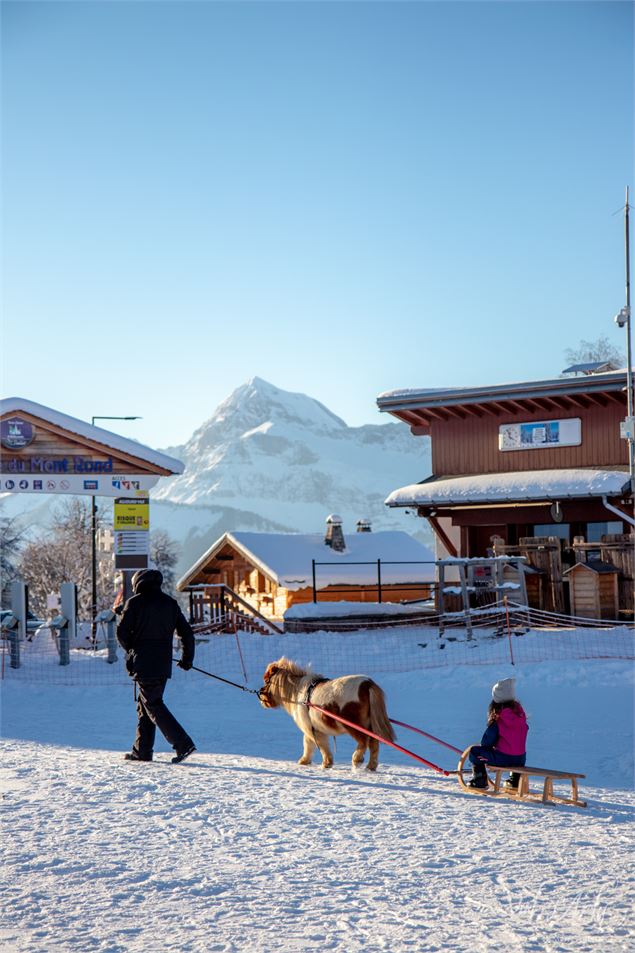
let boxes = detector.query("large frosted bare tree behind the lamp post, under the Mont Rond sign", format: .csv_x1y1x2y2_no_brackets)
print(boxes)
18,498,113,619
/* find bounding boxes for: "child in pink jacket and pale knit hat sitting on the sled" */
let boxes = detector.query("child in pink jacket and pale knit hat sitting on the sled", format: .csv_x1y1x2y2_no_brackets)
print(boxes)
468,678,528,790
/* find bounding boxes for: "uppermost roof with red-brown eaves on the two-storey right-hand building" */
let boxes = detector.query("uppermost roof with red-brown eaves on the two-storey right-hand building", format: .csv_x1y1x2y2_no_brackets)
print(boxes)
377,370,626,434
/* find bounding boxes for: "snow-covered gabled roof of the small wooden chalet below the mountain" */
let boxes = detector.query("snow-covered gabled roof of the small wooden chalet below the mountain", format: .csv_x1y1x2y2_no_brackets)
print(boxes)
177,531,435,590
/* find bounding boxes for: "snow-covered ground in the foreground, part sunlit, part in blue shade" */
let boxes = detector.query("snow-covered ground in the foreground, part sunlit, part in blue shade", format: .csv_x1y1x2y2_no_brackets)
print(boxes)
0,644,635,953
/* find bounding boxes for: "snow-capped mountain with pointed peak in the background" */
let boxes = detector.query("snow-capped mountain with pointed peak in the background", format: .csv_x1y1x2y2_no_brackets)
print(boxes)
152,377,431,566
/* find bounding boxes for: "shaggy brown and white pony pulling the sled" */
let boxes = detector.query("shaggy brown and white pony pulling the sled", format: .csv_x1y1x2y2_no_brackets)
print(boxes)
259,657,395,771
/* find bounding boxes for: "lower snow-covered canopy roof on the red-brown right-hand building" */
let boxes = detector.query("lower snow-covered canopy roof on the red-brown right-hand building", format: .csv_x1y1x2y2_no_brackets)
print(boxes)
385,469,629,506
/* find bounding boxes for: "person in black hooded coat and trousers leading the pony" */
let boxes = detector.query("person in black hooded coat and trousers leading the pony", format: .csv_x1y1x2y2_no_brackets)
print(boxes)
117,569,196,764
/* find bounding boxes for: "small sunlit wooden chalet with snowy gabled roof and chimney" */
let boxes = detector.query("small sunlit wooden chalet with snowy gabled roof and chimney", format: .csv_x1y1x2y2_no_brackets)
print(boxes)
177,517,435,622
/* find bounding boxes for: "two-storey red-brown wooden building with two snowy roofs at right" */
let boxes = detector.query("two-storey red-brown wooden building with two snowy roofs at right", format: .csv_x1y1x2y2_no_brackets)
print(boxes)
377,366,635,617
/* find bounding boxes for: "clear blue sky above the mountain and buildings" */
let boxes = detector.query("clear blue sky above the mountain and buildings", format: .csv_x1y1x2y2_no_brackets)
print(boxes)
2,2,634,447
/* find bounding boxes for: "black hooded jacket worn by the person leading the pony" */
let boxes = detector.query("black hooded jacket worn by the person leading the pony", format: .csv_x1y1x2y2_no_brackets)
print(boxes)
117,569,194,681
